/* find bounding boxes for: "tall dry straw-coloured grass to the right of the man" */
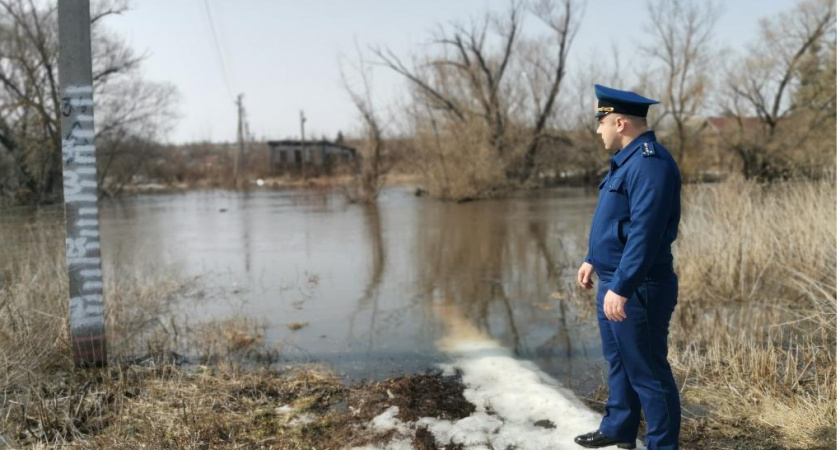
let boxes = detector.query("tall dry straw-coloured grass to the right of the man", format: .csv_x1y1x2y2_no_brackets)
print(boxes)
670,180,837,448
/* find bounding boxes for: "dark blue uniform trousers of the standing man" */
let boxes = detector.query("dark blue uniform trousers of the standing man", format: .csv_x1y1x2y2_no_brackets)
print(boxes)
596,274,680,450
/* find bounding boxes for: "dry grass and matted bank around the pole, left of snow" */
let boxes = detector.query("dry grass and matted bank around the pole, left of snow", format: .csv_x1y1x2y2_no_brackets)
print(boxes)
0,215,480,450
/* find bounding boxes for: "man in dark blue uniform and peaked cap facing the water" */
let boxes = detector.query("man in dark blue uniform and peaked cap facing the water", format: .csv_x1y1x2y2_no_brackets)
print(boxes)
575,84,681,450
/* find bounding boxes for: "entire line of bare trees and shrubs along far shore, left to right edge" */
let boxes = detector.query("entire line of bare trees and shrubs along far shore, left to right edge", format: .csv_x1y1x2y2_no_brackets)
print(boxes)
0,0,837,203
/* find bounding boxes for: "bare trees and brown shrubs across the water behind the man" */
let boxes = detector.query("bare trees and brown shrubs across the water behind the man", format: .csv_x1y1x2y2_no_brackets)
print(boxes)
360,0,837,200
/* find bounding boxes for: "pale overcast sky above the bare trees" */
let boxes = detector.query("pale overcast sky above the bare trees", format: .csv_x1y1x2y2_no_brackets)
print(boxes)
106,0,797,143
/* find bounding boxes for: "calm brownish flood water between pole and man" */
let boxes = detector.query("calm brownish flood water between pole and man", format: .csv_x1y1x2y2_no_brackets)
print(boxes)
0,188,604,391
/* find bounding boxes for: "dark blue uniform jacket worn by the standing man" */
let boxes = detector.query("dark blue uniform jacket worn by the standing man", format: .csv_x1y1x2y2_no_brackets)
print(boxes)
586,131,681,298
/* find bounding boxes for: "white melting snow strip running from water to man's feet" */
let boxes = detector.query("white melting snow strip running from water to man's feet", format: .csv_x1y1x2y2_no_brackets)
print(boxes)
348,304,644,450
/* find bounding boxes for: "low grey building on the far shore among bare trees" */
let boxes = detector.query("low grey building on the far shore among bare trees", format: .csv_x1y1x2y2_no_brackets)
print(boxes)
268,140,356,172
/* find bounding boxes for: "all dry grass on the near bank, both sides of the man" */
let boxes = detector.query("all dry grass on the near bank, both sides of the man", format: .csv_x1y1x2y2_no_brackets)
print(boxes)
0,181,836,450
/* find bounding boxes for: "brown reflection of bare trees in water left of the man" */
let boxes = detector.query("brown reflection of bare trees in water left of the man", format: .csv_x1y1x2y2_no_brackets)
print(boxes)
415,200,588,378
